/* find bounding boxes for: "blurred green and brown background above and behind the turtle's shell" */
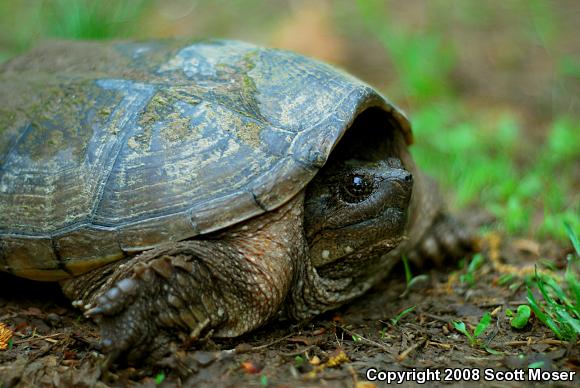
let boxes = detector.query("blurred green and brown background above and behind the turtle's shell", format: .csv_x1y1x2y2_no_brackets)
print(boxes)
0,0,580,241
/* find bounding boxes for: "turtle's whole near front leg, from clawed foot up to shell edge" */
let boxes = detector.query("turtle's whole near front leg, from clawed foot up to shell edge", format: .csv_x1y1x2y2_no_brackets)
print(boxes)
63,197,306,362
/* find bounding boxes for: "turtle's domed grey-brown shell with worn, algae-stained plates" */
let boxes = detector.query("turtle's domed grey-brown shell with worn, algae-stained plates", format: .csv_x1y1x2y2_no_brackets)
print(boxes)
0,41,411,280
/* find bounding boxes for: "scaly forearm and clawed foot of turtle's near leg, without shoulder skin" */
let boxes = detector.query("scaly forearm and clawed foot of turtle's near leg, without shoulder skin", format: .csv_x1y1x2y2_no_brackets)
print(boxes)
63,241,292,362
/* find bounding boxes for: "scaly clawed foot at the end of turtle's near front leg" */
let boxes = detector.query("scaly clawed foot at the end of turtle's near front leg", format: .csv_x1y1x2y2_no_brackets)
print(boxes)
63,244,225,364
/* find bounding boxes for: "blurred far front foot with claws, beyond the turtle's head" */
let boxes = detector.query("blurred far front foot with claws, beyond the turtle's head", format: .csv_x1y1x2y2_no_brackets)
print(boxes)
408,214,477,267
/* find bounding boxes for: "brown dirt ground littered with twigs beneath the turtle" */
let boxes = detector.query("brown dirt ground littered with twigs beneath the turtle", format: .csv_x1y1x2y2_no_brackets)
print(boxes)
0,229,580,388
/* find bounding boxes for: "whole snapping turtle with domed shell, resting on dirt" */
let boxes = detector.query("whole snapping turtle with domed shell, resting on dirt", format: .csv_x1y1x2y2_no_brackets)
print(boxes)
0,41,471,361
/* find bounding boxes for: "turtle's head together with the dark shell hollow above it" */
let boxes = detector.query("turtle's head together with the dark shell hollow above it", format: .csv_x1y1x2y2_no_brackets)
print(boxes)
304,108,414,277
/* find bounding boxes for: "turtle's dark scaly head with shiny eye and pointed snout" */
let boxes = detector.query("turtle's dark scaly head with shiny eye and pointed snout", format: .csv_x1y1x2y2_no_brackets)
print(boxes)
304,160,413,267
